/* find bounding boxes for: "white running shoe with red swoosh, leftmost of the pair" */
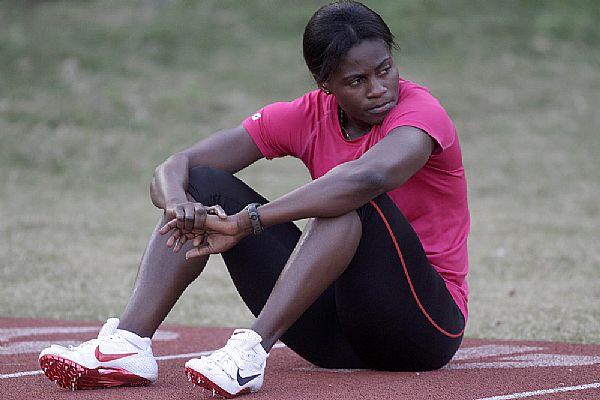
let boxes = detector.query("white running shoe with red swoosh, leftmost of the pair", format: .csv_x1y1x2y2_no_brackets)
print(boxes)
39,318,158,390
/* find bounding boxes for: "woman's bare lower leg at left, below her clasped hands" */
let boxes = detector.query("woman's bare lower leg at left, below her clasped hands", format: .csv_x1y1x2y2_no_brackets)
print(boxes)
119,218,208,337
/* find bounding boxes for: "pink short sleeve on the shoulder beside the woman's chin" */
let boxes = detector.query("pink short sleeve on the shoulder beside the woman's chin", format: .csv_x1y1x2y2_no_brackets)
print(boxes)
383,90,456,154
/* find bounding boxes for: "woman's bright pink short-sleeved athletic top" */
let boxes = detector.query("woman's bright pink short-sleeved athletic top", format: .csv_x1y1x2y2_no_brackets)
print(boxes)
242,79,470,319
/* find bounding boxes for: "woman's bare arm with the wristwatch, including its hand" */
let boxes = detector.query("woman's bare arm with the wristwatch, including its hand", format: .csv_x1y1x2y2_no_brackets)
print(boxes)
176,126,434,258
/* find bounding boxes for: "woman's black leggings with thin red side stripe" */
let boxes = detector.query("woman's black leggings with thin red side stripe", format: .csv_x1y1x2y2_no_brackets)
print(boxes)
189,167,465,371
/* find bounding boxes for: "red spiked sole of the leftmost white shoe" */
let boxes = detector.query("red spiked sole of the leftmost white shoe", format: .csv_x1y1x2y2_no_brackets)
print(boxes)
40,354,152,390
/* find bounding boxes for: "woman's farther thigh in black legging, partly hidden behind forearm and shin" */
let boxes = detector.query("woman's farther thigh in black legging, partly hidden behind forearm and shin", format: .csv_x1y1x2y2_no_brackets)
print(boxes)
188,167,364,368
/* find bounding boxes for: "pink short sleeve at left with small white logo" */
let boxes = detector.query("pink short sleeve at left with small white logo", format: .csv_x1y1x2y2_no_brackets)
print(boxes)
242,99,306,160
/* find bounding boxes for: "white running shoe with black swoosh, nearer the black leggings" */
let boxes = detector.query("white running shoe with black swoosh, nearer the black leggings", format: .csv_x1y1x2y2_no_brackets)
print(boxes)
185,329,269,399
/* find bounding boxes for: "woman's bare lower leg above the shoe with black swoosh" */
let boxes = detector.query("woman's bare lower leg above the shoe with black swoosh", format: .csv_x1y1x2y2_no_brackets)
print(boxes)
252,211,362,351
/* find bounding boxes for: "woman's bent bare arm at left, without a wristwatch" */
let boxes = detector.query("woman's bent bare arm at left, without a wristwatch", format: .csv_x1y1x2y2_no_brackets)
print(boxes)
150,125,262,223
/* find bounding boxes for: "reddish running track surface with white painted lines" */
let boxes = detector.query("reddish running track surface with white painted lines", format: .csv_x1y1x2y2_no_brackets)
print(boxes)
0,318,600,400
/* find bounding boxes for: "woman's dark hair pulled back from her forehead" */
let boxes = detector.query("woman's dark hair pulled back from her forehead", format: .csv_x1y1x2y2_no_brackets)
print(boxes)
302,0,397,83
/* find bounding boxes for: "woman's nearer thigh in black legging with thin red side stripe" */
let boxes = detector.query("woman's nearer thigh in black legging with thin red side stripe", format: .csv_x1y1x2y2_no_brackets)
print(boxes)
335,194,464,370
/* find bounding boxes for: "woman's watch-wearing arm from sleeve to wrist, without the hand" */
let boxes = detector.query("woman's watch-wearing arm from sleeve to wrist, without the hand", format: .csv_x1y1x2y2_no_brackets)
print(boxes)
254,126,434,226
